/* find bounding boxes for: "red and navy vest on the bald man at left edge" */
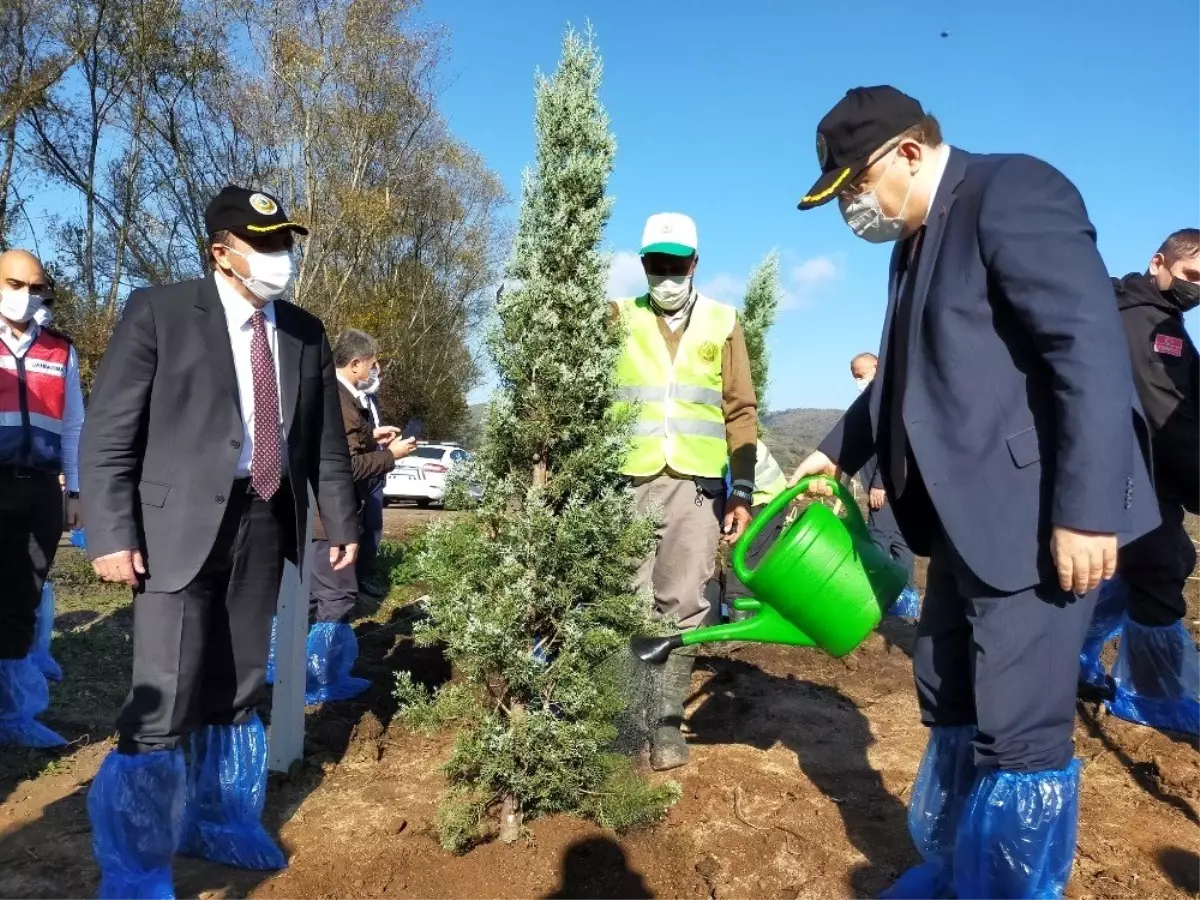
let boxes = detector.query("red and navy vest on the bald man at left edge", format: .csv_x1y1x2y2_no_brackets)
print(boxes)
0,329,71,472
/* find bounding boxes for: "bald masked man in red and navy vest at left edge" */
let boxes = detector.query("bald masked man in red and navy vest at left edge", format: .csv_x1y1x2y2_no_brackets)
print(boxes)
0,250,84,748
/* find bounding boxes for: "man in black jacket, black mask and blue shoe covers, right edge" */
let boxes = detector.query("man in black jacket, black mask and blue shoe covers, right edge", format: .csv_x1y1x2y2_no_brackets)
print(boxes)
1080,228,1200,734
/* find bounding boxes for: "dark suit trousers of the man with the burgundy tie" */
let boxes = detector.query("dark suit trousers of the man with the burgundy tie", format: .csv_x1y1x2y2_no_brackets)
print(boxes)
116,479,295,755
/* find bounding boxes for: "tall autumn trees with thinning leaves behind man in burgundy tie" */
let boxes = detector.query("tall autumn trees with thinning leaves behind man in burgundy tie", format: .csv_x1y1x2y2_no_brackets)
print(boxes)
0,0,509,437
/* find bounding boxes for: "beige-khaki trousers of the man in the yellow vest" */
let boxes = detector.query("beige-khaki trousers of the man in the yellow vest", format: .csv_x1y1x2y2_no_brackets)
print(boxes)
634,473,725,629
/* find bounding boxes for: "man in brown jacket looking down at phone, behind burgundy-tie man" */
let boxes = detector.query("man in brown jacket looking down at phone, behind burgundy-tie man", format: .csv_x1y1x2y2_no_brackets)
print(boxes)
305,329,416,704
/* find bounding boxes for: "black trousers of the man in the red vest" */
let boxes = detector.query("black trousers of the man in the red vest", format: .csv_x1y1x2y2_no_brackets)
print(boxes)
0,467,62,659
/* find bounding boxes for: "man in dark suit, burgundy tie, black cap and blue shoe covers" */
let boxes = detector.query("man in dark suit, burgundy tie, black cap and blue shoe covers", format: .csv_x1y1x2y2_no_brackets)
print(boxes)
80,186,358,896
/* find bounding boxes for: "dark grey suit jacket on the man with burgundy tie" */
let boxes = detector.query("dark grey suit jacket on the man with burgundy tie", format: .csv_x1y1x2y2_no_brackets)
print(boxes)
79,275,359,593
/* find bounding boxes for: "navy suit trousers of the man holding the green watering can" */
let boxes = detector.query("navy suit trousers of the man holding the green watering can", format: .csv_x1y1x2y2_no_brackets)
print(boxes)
913,535,1099,772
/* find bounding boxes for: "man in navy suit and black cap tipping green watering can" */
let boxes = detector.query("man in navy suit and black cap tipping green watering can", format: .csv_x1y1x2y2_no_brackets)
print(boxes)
796,86,1158,900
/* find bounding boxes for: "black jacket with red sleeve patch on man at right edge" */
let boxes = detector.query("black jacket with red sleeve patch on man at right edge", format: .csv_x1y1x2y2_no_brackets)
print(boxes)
1112,272,1200,512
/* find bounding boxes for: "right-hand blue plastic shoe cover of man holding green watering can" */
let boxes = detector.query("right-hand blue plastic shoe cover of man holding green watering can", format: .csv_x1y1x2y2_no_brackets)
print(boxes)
954,760,1080,900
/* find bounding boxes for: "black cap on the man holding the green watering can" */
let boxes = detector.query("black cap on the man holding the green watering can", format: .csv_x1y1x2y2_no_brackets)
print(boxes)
799,84,925,209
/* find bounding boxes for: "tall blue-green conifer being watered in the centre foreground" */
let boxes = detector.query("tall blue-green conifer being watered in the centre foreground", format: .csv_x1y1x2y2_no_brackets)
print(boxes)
397,21,678,851
